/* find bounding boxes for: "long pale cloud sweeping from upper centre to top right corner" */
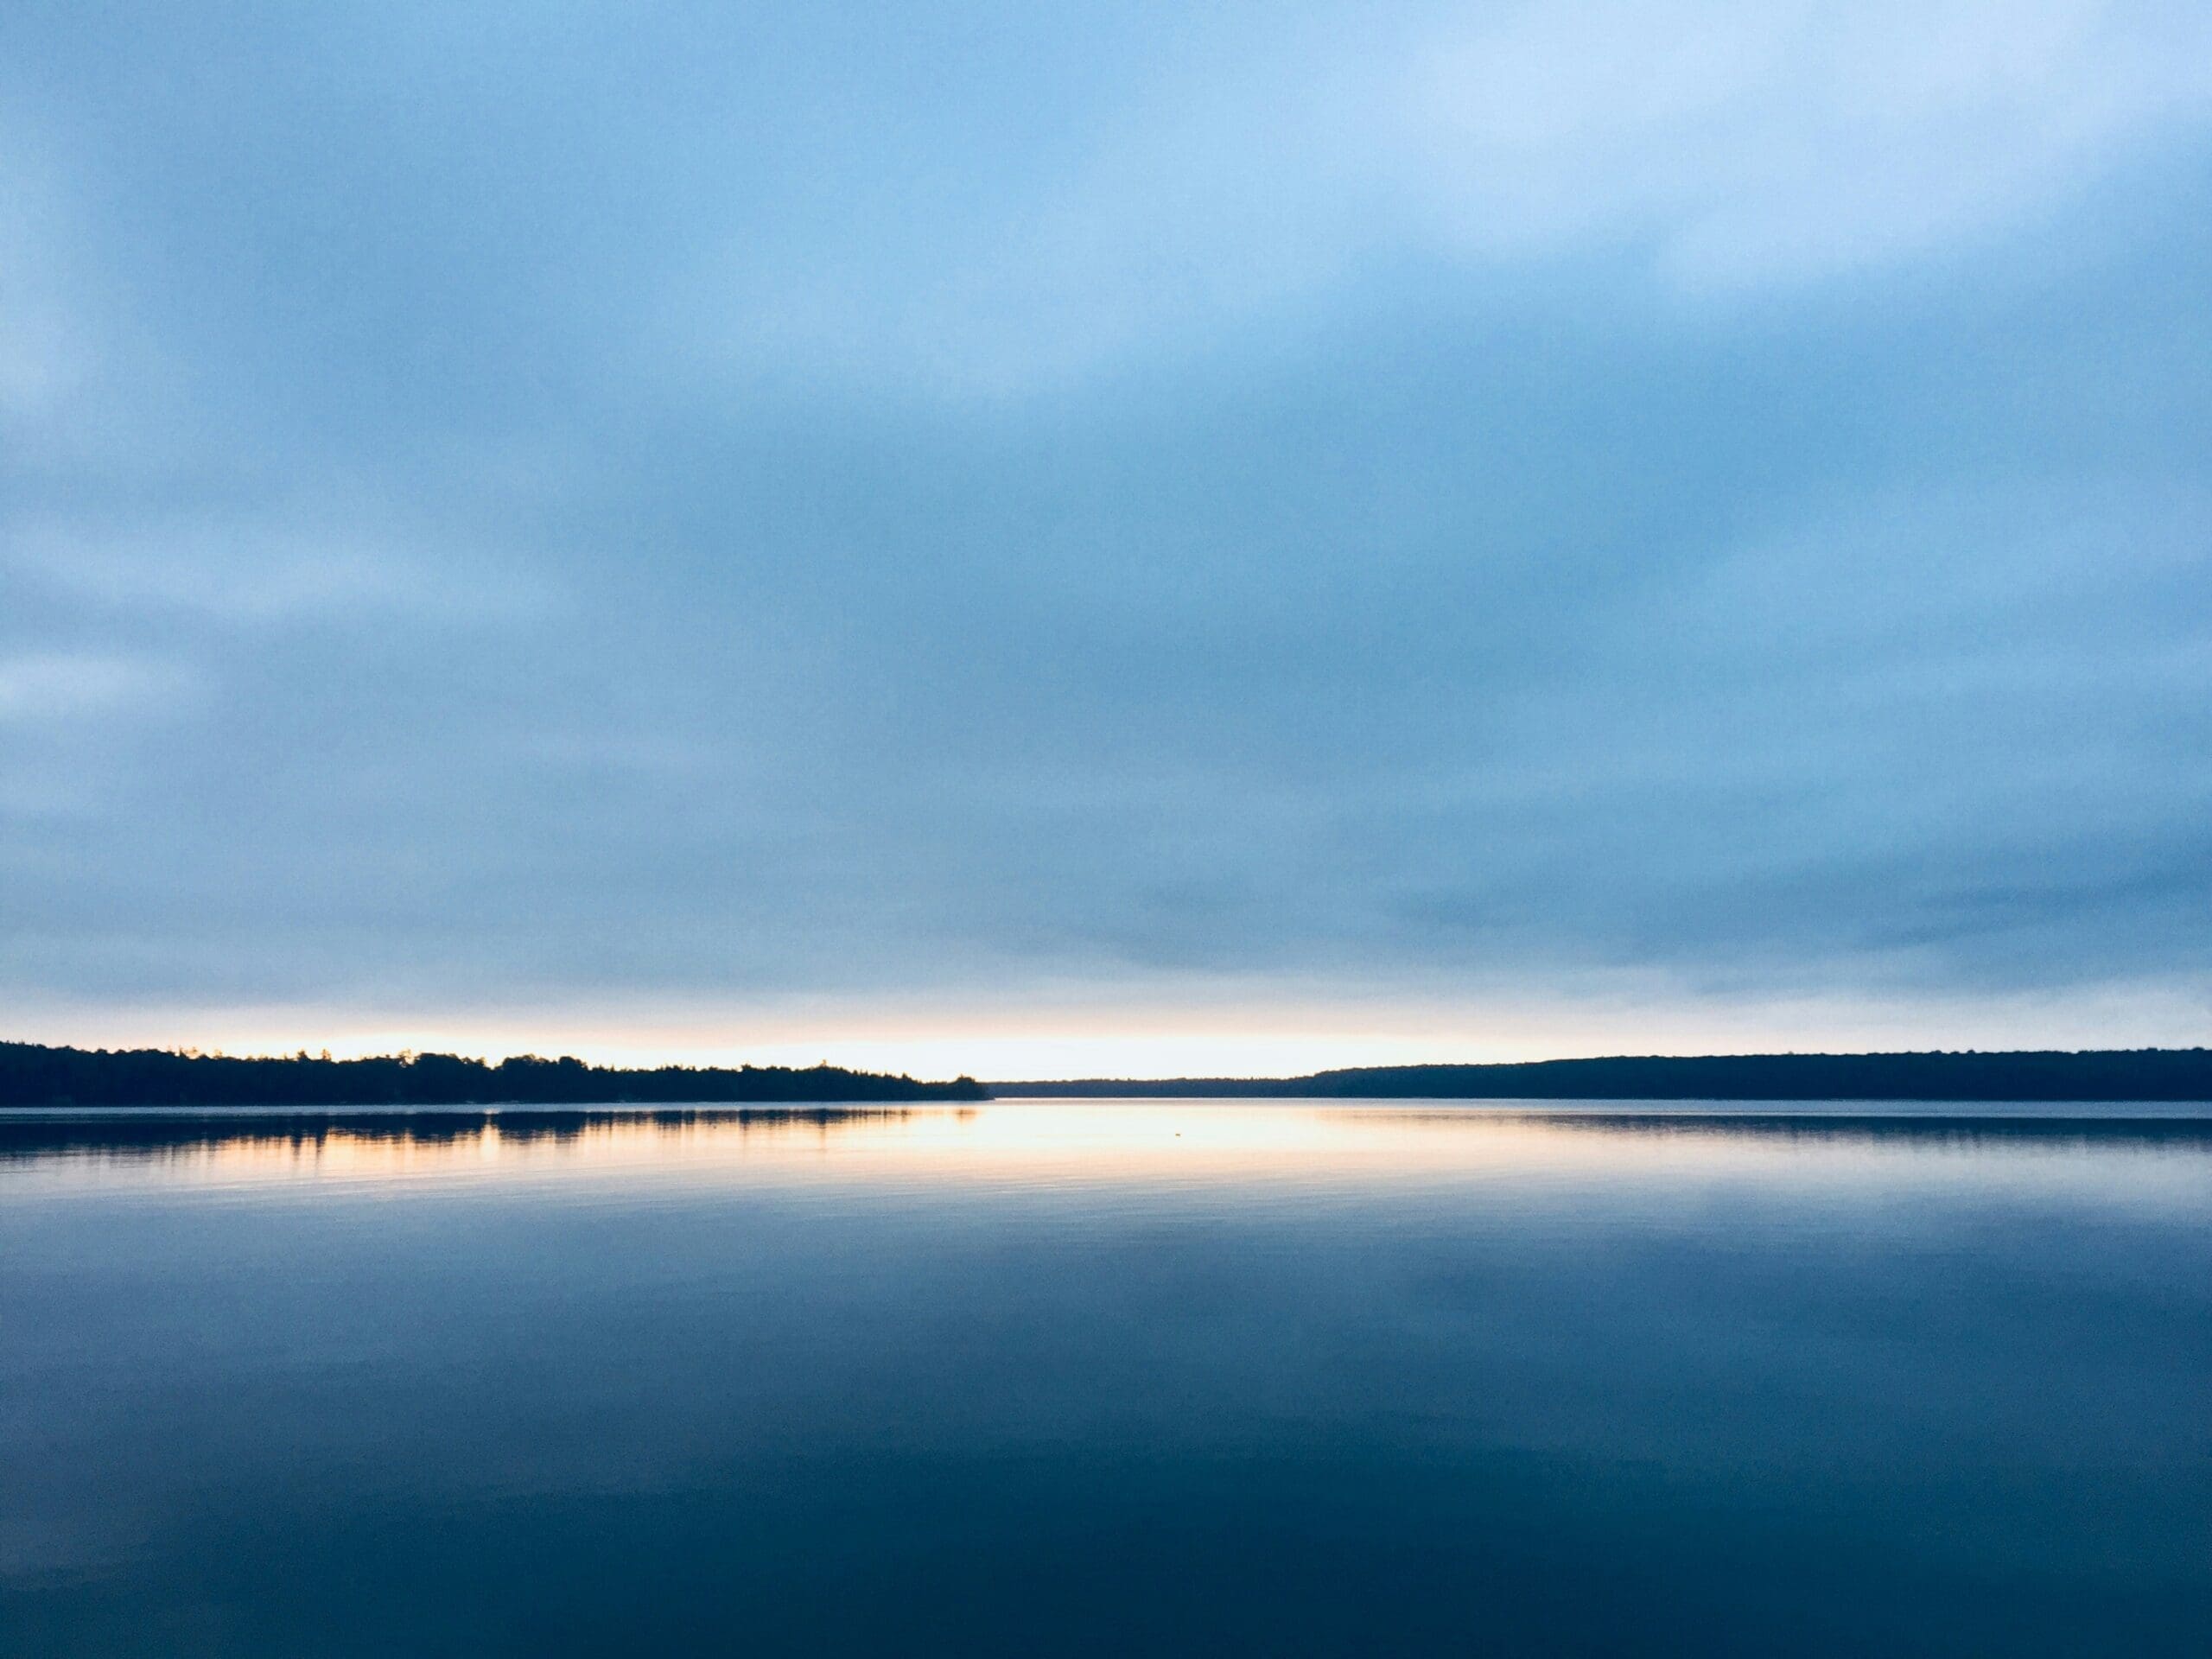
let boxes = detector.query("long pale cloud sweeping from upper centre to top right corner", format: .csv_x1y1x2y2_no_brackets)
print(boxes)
681,0,2212,396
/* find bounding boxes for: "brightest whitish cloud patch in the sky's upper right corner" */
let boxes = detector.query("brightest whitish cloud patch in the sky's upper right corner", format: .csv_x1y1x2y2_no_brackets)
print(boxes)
1411,0,2212,289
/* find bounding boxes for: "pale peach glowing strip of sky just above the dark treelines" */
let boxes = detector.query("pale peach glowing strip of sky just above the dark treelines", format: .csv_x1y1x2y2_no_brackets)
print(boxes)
0,987,2203,1084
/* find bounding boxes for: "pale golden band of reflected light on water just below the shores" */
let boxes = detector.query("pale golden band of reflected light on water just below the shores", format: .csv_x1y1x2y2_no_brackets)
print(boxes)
0,1099,2212,1205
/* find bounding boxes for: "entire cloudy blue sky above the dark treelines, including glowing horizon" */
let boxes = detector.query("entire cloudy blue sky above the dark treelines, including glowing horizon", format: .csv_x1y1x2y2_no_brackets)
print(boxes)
0,0,2212,1077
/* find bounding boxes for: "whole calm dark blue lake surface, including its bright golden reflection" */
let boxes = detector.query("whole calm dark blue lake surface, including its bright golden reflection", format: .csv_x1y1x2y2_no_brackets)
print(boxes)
0,1102,2212,1656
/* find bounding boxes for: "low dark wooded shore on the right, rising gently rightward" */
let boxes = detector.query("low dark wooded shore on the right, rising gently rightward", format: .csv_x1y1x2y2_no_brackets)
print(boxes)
988,1048,2212,1102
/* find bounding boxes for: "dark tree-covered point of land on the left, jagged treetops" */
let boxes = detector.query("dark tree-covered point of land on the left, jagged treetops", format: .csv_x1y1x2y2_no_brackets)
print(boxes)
0,1042,984,1109
